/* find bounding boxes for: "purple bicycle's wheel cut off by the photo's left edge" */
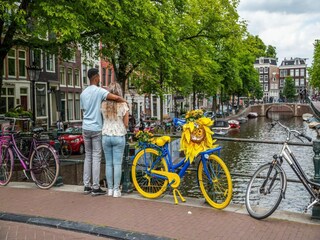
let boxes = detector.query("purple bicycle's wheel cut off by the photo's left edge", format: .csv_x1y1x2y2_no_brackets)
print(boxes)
0,145,14,186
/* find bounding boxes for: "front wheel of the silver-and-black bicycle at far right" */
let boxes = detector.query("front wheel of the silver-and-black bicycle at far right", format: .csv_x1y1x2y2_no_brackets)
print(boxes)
245,163,285,219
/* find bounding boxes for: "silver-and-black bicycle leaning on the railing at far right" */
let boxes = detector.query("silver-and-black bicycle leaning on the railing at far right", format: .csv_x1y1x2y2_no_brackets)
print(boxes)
245,121,320,219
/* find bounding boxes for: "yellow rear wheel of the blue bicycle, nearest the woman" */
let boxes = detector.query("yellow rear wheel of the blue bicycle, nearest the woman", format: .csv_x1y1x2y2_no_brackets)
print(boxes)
131,148,168,198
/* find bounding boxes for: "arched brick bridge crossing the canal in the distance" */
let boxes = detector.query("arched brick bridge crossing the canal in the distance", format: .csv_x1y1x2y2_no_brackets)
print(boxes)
246,103,313,117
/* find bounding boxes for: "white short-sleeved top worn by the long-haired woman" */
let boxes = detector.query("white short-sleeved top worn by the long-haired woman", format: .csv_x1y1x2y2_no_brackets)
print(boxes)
101,102,129,136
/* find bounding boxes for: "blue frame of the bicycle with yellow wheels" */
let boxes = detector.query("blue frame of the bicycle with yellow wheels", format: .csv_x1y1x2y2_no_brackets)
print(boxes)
139,143,221,185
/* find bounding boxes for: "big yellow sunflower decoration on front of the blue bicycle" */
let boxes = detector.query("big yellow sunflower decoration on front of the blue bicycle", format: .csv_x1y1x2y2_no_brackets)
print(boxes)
180,110,216,162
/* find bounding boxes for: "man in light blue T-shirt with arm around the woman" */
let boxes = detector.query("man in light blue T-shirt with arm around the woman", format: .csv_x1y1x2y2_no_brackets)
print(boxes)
80,68,125,196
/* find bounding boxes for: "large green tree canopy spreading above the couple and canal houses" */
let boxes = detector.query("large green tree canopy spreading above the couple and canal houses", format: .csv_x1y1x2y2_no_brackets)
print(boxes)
0,0,268,109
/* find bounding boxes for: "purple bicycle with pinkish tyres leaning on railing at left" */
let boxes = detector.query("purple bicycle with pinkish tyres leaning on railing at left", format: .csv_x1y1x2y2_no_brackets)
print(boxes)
0,118,60,189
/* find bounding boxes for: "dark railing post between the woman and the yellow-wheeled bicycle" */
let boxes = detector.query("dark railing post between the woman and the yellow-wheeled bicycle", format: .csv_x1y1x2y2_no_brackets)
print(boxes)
122,134,133,193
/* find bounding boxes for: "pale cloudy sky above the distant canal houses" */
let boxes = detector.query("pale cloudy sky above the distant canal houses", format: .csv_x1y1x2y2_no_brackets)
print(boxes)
238,0,320,67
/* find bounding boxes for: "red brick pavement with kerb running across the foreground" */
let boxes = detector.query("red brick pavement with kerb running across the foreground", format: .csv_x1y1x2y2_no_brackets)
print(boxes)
0,182,320,240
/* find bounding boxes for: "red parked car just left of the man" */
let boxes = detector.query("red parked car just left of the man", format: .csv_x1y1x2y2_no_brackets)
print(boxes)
60,126,85,154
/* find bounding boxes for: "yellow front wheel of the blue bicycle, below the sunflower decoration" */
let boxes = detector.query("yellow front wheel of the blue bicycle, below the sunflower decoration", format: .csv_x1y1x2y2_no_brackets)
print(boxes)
198,154,232,209
